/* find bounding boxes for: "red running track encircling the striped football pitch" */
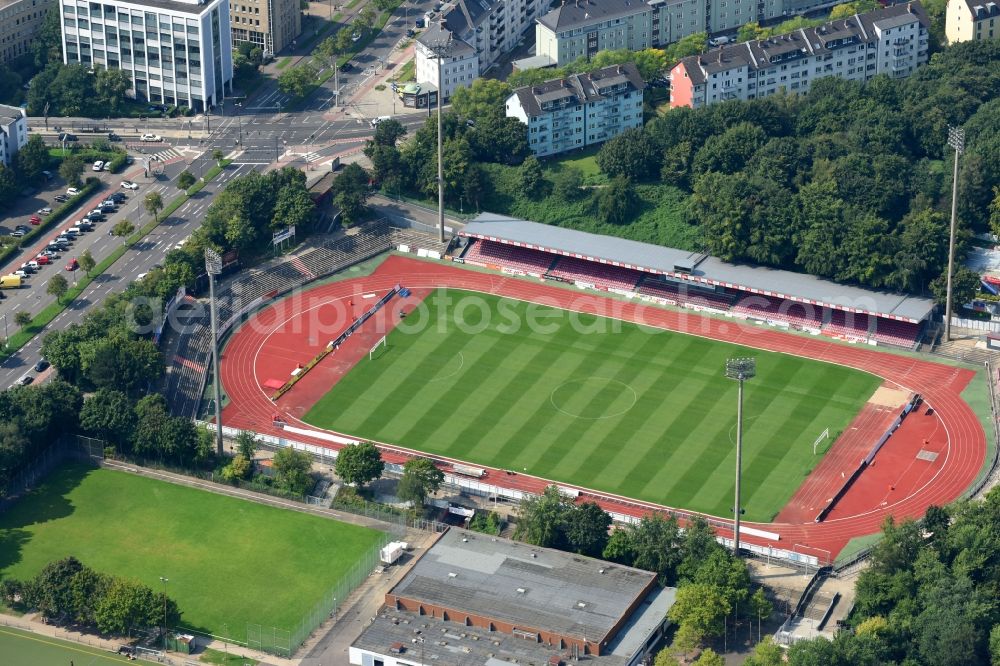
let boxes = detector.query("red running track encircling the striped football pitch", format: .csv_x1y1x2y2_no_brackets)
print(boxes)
221,256,986,556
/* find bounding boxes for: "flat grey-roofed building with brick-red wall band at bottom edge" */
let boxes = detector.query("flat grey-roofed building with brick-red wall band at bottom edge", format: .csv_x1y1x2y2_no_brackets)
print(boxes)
350,529,675,666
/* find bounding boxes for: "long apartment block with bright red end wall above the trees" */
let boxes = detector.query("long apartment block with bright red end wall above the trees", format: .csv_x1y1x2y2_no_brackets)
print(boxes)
670,2,929,108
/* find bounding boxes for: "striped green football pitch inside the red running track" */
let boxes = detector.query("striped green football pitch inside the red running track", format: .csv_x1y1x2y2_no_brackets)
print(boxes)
305,291,880,521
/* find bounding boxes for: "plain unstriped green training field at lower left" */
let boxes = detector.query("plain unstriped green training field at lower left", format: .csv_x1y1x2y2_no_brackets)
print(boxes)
0,465,383,644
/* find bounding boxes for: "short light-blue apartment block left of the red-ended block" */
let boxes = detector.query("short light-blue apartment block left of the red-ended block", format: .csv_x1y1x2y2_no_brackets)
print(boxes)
506,64,645,157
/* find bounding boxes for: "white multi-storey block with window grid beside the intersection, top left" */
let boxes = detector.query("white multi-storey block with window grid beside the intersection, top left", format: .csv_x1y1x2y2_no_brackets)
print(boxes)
59,0,233,112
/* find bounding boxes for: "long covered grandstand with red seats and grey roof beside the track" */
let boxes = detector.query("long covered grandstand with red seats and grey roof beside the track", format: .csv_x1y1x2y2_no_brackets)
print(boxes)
460,213,934,348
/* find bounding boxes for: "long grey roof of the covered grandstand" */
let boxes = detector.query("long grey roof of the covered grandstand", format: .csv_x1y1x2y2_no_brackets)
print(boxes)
461,213,934,323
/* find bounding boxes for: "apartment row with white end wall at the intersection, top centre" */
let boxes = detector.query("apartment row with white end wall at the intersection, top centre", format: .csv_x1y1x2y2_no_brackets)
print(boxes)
415,0,548,99
